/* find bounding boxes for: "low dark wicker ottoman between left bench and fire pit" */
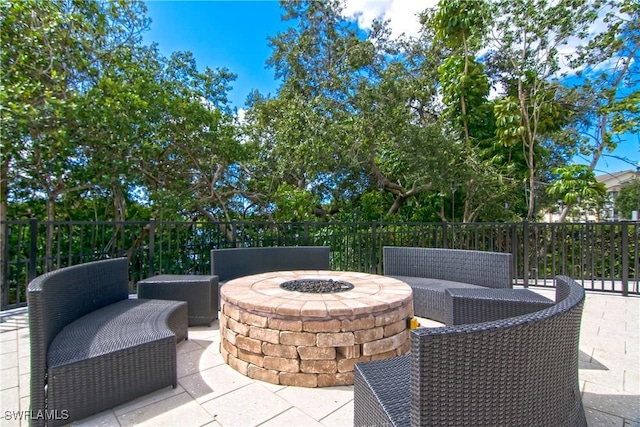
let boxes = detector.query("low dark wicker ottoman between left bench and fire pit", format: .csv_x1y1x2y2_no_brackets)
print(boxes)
138,274,218,326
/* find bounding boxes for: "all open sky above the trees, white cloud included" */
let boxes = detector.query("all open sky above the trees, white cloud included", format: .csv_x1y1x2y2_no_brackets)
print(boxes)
144,0,640,174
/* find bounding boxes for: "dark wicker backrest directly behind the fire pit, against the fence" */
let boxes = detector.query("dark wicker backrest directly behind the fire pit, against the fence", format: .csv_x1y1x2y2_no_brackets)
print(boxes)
211,246,329,282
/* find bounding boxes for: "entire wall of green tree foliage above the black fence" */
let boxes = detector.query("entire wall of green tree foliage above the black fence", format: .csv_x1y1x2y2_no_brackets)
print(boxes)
0,0,640,231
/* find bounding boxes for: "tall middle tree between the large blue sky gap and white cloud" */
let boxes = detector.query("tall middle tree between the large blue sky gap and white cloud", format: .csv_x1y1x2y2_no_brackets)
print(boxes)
246,1,371,219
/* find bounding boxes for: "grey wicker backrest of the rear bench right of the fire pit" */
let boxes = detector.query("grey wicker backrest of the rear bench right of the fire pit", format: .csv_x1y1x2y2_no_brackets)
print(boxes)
383,246,513,288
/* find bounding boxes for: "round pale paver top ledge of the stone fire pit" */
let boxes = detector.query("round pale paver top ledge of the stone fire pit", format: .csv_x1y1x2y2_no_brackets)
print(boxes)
221,270,412,318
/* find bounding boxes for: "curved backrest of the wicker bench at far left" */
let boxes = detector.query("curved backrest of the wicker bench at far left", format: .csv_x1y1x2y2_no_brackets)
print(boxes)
27,258,129,422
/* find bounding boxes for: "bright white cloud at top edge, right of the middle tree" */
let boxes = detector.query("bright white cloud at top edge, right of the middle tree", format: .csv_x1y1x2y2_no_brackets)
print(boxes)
343,0,438,38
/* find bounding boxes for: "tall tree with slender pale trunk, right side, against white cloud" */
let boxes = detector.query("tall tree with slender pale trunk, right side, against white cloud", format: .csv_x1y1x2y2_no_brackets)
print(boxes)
487,0,595,220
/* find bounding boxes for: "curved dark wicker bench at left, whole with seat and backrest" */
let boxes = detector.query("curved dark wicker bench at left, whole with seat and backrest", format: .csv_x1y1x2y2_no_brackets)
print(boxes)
27,258,188,426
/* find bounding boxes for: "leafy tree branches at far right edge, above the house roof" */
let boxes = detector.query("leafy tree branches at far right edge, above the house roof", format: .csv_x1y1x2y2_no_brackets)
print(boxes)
561,0,640,218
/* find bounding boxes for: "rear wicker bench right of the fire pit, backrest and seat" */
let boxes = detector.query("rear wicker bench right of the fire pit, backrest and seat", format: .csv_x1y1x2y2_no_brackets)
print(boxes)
383,246,513,323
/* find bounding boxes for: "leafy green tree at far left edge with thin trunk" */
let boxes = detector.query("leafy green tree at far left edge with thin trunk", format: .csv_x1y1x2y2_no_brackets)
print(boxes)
0,0,154,274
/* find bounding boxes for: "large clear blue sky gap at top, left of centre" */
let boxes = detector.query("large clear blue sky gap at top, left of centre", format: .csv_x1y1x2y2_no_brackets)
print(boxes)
144,1,288,108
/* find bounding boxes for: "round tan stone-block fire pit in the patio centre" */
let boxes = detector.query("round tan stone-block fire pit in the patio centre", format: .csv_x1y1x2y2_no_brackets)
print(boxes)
220,271,413,387
